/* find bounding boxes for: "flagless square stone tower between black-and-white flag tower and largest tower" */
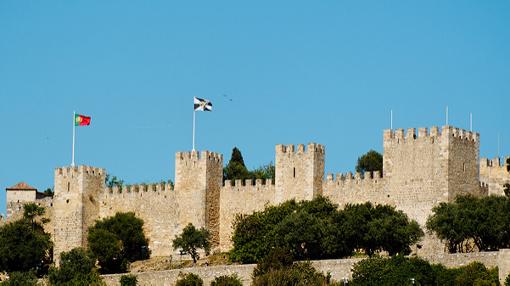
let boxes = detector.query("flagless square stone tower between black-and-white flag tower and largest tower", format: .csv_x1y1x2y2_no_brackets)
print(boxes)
275,143,325,203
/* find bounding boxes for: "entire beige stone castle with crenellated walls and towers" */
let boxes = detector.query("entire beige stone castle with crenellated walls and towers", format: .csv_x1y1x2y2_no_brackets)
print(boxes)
3,126,510,258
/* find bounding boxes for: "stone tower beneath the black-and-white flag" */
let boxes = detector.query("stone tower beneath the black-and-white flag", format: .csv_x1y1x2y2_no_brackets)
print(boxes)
175,151,223,246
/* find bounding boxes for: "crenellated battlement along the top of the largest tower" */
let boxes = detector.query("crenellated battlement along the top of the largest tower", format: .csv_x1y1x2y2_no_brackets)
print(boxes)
384,125,480,143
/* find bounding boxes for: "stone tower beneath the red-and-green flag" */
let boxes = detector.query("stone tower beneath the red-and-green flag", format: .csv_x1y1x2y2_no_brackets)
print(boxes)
53,166,105,263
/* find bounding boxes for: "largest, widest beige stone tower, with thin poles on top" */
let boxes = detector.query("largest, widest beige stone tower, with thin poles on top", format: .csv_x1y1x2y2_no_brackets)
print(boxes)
383,126,480,225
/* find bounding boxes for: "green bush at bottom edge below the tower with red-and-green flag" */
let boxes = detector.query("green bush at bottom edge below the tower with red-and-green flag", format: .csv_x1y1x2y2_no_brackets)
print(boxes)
48,248,105,286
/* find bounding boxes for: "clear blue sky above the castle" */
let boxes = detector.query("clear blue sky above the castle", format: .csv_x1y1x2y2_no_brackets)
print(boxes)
0,0,510,213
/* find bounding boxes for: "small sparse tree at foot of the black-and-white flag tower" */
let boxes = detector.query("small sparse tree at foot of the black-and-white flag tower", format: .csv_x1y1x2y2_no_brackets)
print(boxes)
173,223,211,264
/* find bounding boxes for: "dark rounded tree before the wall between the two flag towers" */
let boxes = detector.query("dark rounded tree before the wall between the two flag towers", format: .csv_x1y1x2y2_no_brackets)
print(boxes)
88,212,150,273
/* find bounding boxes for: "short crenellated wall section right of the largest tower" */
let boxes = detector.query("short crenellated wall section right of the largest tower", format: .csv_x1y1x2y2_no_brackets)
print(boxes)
480,157,510,196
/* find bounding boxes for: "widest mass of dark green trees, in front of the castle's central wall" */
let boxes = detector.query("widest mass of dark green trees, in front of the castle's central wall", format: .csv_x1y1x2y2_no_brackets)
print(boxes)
230,197,423,263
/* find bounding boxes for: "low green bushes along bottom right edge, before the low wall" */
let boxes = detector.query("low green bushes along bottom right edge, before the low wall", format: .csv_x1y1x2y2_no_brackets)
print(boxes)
349,255,499,286
